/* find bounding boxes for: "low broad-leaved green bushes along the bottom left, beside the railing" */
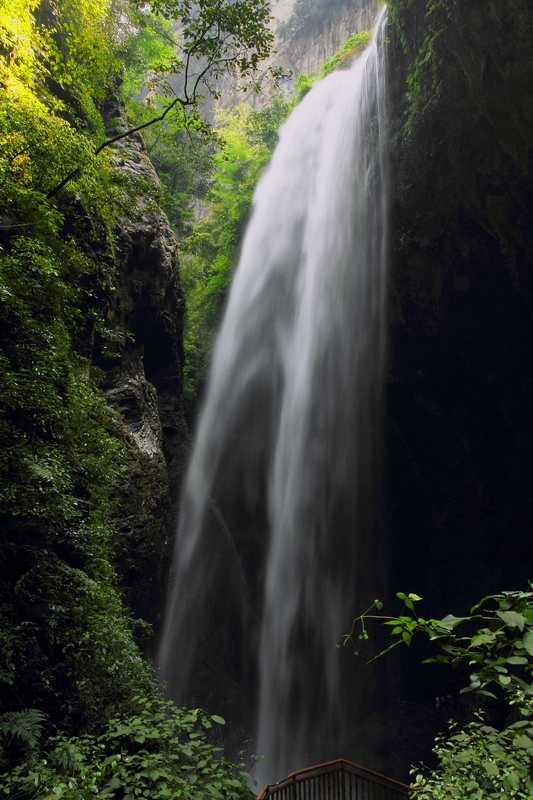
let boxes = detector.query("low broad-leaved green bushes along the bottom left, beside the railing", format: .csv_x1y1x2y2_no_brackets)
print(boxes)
0,697,250,800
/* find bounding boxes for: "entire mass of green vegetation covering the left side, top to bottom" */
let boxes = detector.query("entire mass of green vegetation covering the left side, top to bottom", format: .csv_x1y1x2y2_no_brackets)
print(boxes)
0,0,271,798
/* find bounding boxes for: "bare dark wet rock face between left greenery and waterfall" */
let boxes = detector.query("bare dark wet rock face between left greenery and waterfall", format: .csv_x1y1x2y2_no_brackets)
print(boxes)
98,123,187,630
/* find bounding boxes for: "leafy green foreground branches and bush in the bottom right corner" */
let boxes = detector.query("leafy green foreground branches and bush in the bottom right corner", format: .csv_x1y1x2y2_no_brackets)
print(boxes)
344,591,533,800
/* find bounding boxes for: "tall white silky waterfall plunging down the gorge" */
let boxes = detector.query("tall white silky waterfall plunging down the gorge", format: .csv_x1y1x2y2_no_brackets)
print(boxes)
160,9,388,781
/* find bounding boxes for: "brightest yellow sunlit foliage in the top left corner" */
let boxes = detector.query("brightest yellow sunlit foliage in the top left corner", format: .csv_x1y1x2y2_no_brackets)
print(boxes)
0,0,139,132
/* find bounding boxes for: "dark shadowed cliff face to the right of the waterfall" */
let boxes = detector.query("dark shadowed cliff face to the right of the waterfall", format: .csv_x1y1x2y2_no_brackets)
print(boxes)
385,0,533,756
